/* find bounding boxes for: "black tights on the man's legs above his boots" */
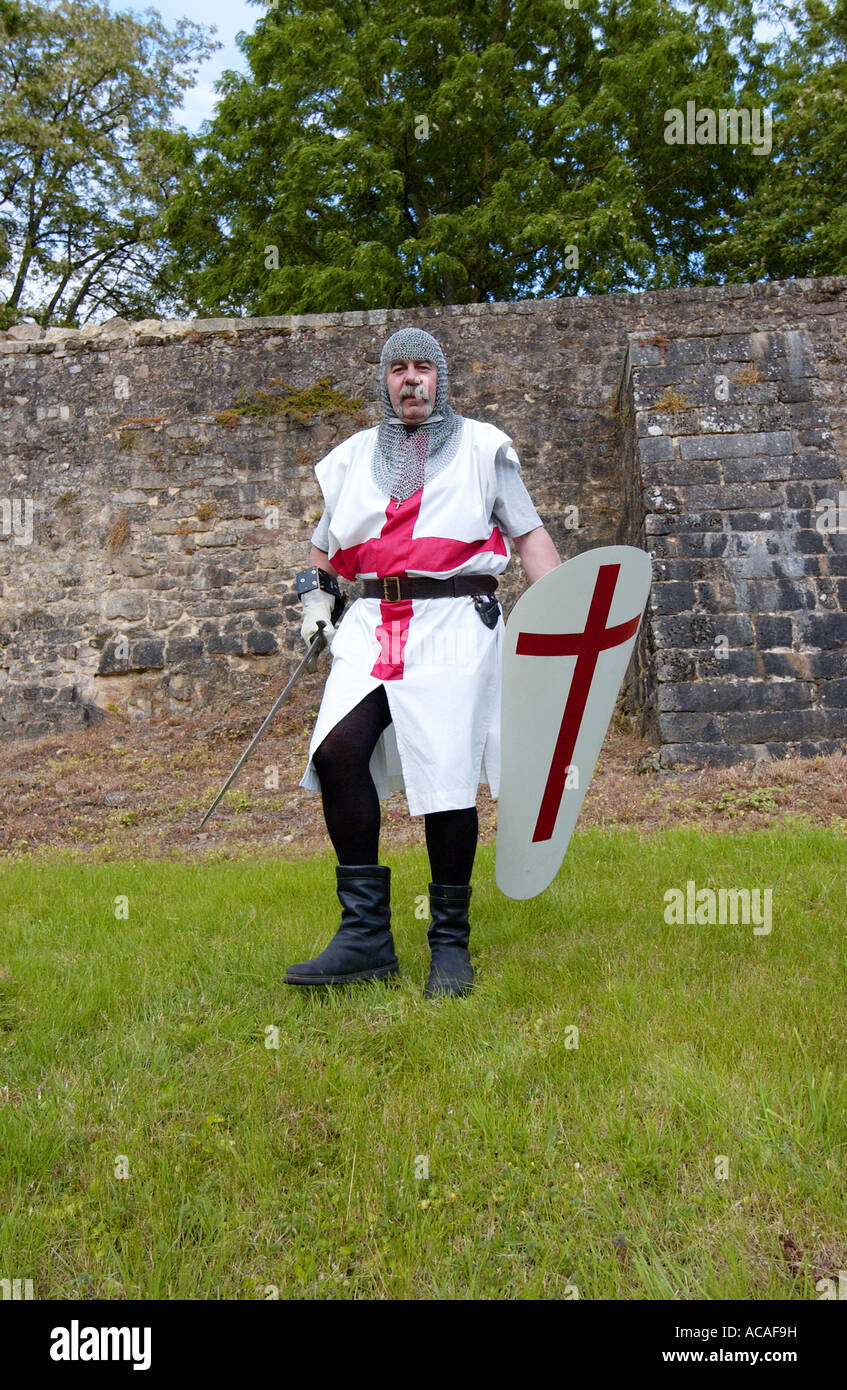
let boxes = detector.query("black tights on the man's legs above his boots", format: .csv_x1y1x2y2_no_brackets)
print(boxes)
313,685,478,884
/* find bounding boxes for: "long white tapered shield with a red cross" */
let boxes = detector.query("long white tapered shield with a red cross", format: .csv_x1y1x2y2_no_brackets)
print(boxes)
497,545,651,898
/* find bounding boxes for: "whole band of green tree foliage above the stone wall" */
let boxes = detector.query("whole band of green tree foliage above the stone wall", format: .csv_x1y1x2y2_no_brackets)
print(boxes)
6,0,847,327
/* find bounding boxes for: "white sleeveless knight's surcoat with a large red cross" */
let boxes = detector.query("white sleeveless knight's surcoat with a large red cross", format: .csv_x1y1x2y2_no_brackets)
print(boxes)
300,418,520,816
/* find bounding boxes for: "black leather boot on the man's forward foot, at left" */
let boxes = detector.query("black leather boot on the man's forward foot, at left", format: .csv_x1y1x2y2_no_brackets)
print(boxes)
285,865,399,984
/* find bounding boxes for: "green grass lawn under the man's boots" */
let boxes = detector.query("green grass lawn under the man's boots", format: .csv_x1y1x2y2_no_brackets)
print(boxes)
0,828,847,1300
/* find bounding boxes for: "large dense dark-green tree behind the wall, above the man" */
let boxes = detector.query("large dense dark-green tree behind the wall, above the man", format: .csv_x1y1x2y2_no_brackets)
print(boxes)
155,0,769,314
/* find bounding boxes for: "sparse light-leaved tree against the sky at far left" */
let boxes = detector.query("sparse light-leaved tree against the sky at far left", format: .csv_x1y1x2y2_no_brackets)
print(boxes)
0,0,220,328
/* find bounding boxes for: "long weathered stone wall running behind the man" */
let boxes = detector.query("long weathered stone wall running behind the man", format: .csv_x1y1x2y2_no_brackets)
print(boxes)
0,278,847,760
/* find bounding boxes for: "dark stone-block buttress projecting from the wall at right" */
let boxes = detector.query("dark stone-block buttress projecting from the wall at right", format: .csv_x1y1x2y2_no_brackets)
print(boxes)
623,329,847,766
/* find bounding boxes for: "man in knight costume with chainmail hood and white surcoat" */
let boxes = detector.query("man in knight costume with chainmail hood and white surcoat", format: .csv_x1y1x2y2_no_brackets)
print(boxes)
285,328,560,998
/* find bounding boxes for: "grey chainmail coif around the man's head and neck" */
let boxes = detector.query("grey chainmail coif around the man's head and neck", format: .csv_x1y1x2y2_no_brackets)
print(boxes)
371,328,463,502
